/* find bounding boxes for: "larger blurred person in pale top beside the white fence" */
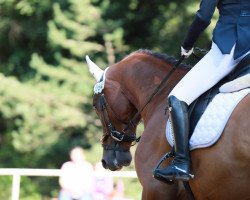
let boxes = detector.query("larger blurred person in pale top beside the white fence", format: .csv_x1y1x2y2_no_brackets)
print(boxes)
59,147,94,200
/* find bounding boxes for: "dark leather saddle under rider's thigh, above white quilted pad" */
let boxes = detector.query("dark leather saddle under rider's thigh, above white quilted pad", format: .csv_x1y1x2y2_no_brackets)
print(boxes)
189,54,250,137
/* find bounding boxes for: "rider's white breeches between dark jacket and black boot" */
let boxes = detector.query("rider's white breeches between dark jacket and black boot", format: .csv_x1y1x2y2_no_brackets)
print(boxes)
169,43,249,105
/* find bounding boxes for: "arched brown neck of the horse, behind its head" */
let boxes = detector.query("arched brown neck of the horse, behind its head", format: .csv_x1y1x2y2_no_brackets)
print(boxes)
107,53,187,122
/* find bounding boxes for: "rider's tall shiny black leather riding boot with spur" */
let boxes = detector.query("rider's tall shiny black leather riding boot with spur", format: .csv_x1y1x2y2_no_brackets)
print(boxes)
154,96,194,181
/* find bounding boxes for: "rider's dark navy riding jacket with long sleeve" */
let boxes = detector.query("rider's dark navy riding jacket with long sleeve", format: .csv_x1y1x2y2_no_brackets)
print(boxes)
183,0,250,59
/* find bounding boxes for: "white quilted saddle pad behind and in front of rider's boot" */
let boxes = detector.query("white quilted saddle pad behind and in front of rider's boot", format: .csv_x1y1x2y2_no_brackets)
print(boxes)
166,88,250,150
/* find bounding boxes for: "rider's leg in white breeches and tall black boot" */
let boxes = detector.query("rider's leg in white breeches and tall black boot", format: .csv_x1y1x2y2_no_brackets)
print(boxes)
154,44,245,181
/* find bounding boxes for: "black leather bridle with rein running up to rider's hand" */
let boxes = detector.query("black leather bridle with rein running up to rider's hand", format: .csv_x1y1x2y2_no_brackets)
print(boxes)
93,56,184,151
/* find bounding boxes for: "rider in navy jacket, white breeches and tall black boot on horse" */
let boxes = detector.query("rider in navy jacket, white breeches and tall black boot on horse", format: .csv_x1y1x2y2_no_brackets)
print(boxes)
154,0,250,181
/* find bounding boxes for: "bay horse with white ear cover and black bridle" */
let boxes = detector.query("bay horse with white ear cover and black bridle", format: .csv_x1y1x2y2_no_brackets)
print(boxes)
87,50,250,200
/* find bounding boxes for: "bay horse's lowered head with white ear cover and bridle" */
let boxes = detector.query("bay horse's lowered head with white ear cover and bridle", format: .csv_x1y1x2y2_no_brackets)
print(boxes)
86,57,140,171
